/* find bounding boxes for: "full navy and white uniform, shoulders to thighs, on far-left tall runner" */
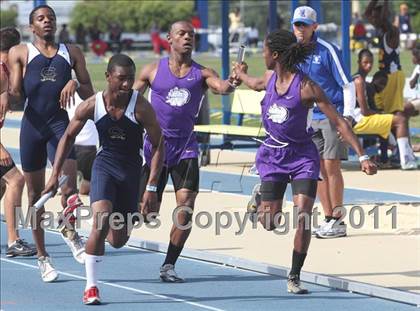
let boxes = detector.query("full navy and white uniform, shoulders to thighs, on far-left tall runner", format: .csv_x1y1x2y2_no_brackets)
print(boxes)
20,43,76,172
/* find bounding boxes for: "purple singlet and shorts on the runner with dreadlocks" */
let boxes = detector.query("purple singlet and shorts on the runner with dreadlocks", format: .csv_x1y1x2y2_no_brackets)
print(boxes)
256,72,320,182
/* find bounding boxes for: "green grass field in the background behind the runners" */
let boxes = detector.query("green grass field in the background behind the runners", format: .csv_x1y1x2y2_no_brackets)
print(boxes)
88,51,420,127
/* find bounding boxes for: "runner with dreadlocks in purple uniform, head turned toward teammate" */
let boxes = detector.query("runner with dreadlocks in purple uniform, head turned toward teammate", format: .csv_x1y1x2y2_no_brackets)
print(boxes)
234,30,376,294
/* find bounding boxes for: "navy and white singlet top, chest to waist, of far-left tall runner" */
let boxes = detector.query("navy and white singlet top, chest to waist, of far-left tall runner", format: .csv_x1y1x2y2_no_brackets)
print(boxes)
23,43,72,123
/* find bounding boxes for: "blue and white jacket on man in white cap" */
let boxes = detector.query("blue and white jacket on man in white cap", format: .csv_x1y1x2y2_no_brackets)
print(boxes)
299,34,352,120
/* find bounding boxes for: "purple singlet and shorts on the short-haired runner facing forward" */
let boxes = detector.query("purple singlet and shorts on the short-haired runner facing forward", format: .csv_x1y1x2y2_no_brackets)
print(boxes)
144,58,205,167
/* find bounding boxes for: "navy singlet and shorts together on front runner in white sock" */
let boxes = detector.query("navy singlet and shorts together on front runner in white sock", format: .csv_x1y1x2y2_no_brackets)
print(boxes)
90,91,144,215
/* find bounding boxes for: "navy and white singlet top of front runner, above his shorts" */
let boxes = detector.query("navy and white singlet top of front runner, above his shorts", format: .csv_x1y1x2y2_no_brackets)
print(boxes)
94,91,144,164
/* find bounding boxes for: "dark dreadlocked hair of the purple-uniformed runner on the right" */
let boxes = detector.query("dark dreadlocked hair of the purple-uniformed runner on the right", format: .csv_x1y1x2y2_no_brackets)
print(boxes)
266,29,315,72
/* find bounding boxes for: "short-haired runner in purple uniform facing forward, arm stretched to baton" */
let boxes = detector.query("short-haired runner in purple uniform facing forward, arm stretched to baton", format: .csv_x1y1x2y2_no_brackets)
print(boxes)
134,21,241,282
